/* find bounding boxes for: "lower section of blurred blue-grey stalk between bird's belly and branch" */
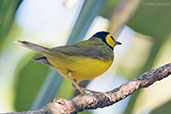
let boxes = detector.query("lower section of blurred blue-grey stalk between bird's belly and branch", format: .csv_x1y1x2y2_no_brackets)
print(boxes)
31,69,63,110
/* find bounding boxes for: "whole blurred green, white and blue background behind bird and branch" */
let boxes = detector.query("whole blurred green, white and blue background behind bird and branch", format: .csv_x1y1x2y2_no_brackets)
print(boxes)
0,0,171,114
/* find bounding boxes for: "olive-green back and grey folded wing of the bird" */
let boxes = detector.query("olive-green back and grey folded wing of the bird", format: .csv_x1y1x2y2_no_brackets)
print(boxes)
52,39,114,60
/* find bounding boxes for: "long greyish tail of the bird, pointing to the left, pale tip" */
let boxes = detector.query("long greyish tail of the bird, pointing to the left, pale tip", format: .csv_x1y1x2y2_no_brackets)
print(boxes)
17,40,52,54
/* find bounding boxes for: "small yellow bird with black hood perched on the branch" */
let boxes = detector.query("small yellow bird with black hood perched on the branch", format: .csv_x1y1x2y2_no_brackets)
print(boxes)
17,31,121,94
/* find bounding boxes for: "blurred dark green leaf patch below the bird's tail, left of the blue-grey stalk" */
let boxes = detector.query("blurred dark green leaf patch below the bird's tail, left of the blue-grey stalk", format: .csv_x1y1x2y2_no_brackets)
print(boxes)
14,56,49,111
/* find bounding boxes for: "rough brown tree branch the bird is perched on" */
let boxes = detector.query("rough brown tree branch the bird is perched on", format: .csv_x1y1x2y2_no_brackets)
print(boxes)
4,63,171,114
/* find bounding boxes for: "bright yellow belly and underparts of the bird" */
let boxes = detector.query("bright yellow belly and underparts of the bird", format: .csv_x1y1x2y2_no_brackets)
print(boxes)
45,54,113,82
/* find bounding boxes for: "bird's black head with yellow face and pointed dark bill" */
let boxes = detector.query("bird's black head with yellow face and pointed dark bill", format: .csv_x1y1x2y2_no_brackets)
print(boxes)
92,31,121,50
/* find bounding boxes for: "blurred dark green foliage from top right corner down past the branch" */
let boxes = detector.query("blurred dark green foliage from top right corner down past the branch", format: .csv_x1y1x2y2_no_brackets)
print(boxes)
125,0,171,114
